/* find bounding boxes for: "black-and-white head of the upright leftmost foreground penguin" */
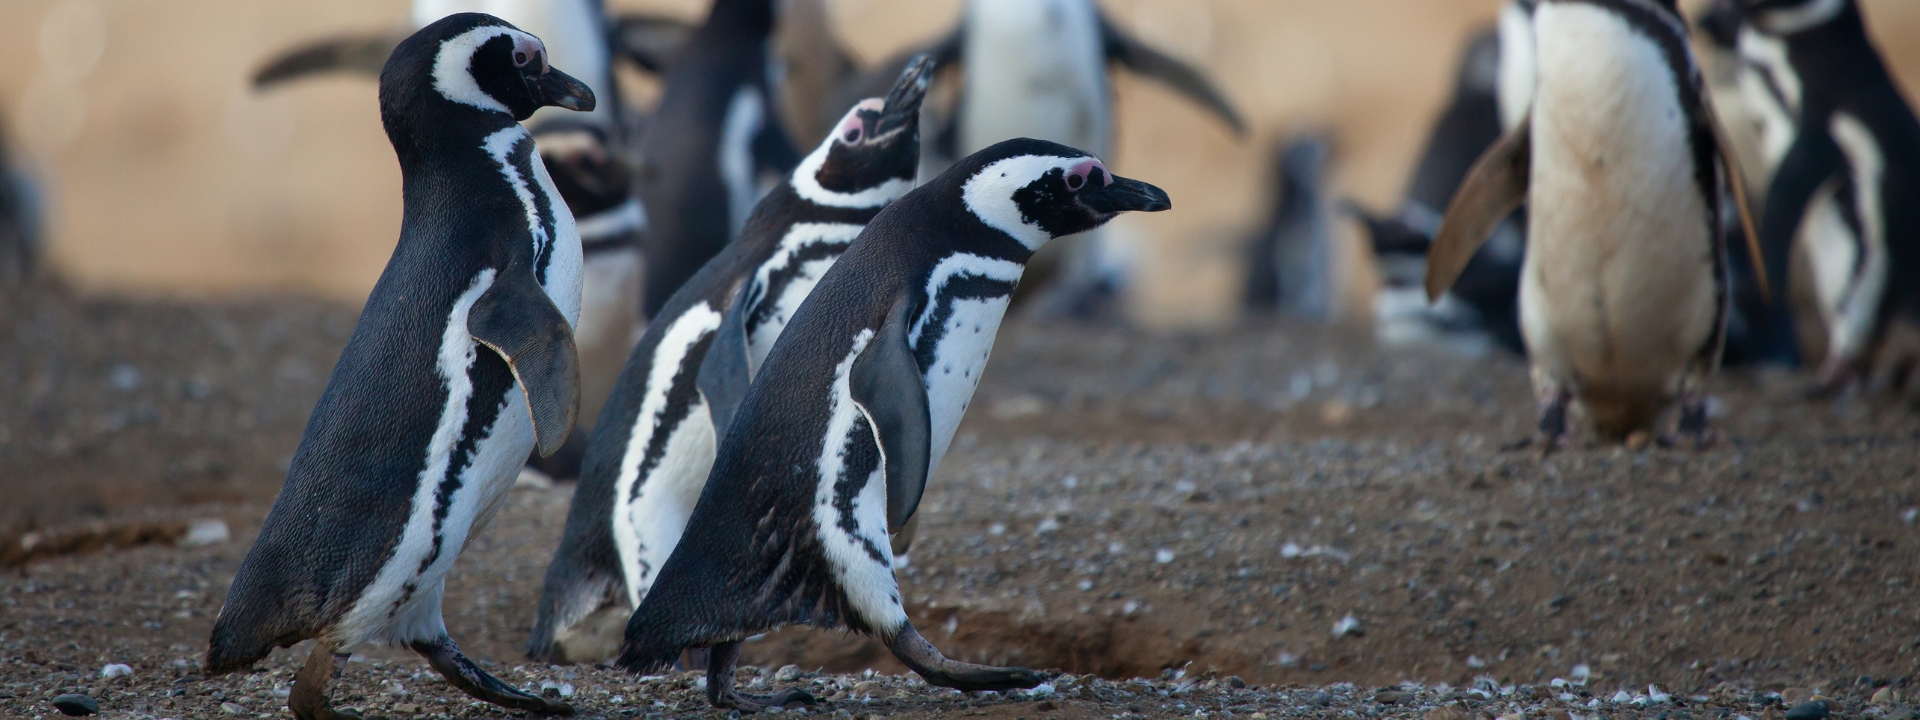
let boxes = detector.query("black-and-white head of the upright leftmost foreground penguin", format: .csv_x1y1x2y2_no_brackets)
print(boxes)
380,13,593,134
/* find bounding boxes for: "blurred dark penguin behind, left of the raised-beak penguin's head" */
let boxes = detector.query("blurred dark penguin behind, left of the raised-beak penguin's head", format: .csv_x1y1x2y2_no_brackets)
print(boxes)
639,0,801,319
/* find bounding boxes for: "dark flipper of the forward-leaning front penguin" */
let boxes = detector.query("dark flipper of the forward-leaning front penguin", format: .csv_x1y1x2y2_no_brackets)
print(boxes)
849,298,933,532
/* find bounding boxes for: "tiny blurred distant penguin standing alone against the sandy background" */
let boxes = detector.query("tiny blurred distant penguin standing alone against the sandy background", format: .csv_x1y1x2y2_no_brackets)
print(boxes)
1242,136,1338,323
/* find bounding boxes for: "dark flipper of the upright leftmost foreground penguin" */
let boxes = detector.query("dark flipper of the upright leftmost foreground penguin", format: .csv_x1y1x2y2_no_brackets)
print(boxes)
467,265,580,457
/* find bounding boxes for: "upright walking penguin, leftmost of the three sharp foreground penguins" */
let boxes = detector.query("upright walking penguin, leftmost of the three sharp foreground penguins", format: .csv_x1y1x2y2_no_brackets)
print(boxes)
207,13,593,718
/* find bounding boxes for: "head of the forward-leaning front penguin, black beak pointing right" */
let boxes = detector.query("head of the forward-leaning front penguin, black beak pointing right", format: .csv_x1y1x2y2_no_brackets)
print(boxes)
943,138,1173,250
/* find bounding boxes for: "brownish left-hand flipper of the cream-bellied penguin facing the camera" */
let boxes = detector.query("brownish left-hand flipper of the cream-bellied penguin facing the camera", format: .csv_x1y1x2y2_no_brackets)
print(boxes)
1427,117,1532,300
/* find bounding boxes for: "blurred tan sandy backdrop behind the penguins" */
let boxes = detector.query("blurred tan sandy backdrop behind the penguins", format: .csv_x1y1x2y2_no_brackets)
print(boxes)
0,0,1920,324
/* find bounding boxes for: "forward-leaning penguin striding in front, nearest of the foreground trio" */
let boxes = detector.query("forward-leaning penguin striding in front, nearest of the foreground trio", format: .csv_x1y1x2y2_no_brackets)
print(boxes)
618,140,1171,708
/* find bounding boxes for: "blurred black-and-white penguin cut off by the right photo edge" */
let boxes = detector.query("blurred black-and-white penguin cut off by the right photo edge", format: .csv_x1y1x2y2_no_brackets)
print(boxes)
1740,0,1920,390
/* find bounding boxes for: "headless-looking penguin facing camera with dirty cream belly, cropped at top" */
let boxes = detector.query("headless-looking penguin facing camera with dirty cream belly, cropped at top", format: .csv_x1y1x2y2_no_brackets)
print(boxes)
1427,0,1757,451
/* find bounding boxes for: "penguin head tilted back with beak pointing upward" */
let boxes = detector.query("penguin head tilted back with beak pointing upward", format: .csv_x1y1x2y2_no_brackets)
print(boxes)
793,54,933,207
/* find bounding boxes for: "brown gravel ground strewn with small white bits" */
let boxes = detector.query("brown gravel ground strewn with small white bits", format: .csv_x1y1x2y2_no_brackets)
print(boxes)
0,288,1920,720
